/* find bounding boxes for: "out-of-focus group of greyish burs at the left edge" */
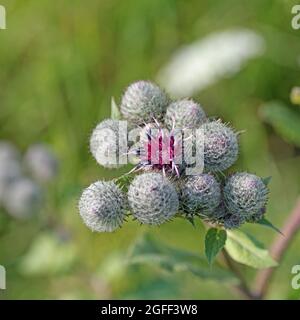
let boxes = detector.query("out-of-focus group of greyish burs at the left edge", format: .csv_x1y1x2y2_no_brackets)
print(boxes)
0,140,58,219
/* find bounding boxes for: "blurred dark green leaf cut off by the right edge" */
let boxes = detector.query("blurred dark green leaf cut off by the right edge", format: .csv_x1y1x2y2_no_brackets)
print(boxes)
260,101,300,146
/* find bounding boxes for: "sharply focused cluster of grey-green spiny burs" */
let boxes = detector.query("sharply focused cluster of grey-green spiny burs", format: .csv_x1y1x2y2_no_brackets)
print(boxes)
79,81,268,232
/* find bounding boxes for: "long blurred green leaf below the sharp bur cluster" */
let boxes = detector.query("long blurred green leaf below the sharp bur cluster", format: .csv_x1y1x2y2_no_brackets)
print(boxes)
127,234,238,282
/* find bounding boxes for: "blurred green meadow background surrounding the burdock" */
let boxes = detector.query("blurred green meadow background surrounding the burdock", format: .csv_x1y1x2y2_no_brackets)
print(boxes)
0,0,300,299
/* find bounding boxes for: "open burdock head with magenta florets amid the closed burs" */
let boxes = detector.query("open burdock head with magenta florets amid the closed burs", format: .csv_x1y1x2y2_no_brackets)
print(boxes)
136,122,183,176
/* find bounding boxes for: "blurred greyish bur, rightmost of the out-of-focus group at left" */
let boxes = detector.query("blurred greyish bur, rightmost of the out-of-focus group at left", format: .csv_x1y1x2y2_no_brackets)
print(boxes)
24,144,58,182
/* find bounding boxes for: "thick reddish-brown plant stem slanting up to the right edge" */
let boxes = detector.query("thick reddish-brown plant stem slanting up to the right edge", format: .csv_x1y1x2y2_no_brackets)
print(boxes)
255,198,300,299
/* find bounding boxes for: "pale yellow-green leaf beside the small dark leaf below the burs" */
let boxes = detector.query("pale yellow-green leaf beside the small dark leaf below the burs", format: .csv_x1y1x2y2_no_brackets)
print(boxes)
225,230,277,269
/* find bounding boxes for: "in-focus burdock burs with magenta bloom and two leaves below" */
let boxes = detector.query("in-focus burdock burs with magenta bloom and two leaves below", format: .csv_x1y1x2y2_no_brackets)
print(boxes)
79,81,284,297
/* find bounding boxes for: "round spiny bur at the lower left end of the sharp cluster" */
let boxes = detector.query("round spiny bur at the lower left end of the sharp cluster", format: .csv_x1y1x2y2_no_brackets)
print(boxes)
79,181,127,232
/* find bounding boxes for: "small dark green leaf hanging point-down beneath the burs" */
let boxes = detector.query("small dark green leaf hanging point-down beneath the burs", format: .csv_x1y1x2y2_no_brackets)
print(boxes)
205,228,227,265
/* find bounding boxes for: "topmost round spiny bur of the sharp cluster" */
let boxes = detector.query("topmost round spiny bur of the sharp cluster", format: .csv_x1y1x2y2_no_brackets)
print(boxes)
120,81,170,124
